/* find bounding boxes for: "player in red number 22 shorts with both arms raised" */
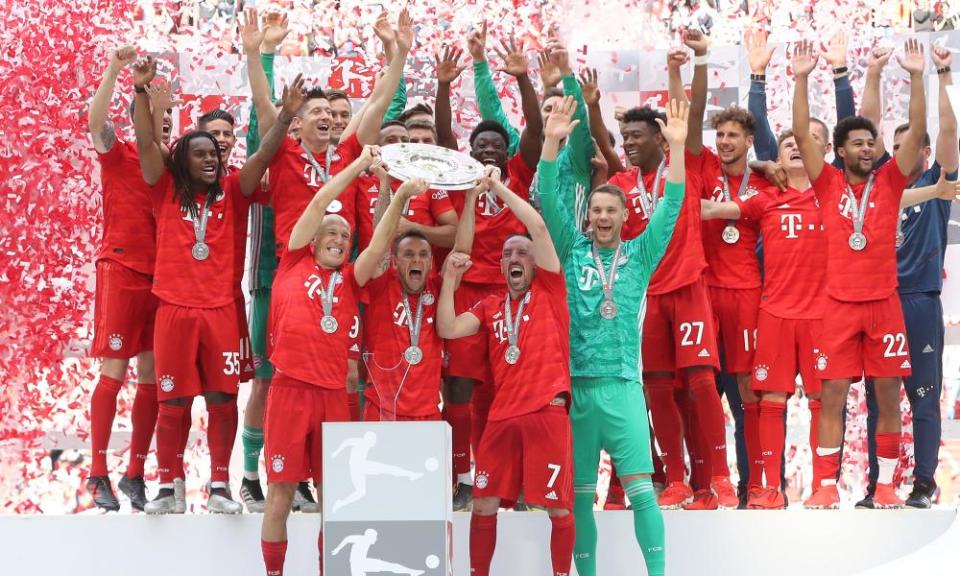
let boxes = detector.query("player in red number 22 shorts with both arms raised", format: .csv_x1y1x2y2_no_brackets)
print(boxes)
793,39,926,508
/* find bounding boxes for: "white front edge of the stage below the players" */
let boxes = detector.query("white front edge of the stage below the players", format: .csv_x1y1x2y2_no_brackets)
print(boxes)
0,509,960,576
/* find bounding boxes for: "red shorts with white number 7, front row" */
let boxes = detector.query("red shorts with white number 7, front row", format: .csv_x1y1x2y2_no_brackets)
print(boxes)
474,406,573,510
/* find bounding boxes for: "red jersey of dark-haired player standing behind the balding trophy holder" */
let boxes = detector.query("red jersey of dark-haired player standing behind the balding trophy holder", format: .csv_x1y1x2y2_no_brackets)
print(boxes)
270,134,363,258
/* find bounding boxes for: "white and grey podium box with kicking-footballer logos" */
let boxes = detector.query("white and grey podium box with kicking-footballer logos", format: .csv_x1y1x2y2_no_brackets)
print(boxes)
323,422,453,576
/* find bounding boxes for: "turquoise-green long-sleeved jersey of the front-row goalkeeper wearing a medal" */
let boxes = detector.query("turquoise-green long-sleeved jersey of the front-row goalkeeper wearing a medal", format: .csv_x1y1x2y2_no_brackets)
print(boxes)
537,160,684,383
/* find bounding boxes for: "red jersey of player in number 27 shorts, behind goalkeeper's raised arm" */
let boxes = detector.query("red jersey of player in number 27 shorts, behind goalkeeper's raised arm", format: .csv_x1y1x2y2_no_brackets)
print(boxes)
610,152,707,294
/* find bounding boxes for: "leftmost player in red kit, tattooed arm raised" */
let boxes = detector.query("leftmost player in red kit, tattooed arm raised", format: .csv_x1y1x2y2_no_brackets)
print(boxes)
87,46,171,511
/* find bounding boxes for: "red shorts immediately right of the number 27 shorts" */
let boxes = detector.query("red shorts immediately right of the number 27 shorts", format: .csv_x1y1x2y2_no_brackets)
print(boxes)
710,286,760,374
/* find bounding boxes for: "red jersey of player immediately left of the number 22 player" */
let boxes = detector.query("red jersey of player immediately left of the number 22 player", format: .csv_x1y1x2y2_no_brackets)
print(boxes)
733,185,827,320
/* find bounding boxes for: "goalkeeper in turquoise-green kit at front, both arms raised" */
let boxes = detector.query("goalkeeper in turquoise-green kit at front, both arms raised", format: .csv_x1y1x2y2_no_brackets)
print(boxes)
537,96,687,576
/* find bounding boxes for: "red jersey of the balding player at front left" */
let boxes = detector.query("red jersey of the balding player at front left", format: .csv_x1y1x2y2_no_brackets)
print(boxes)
270,245,360,389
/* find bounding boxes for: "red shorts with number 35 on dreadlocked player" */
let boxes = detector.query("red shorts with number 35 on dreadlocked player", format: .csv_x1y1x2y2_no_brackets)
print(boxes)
153,302,246,401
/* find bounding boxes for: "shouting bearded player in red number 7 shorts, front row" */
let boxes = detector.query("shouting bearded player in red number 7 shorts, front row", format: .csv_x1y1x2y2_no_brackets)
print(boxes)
437,165,575,576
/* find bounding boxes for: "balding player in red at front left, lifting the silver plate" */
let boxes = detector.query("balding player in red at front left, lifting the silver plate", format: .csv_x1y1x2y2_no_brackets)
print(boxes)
261,141,426,576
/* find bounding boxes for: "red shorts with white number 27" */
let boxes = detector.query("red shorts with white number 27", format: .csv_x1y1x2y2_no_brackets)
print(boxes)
641,277,720,373
